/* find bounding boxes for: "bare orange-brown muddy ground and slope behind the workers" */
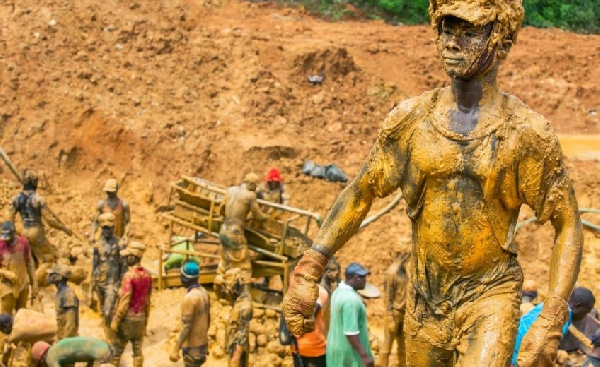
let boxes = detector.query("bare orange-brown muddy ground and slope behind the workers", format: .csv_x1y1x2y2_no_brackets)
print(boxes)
0,0,600,366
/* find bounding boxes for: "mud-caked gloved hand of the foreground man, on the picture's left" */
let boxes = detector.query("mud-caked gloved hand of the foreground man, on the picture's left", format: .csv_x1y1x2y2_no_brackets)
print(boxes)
283,249,329,336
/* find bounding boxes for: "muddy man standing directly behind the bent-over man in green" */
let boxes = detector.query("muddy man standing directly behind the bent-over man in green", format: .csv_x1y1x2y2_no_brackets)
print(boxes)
48,265,79,342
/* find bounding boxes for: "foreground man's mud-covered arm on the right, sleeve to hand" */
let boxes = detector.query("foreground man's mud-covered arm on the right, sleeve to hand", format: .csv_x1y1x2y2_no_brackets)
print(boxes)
517,119,583,367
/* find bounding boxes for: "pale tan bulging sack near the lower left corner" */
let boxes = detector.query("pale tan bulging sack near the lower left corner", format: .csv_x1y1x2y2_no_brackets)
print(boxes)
8,308,56,343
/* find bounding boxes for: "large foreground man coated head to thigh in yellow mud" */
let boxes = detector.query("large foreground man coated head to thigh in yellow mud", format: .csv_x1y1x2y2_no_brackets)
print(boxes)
284,0,583,367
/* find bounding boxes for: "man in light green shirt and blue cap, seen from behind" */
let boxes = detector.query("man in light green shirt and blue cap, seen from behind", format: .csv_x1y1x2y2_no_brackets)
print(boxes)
327,263,374,367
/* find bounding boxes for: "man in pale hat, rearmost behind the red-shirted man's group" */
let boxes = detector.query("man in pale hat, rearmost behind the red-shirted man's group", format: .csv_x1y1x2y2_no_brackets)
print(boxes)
90,178,131,242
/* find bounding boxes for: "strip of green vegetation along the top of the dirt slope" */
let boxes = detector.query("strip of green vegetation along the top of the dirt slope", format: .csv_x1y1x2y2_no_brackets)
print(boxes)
288,0,600,33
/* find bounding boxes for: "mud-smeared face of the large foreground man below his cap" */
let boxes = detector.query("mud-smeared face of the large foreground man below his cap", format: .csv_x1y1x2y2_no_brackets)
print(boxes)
437,16,494,79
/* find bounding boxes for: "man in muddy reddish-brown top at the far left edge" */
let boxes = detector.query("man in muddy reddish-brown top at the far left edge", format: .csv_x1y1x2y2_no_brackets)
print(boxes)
0,220,38,314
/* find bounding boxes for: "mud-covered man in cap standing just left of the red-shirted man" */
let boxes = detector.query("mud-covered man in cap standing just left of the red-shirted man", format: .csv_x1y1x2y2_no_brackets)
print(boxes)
90,213,125,340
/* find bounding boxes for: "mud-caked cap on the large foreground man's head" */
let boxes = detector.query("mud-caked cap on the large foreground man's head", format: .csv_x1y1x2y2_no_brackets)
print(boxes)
429,0,525,51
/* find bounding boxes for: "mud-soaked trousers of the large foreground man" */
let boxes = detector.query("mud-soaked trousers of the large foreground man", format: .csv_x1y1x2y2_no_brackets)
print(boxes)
404,259,523,367
